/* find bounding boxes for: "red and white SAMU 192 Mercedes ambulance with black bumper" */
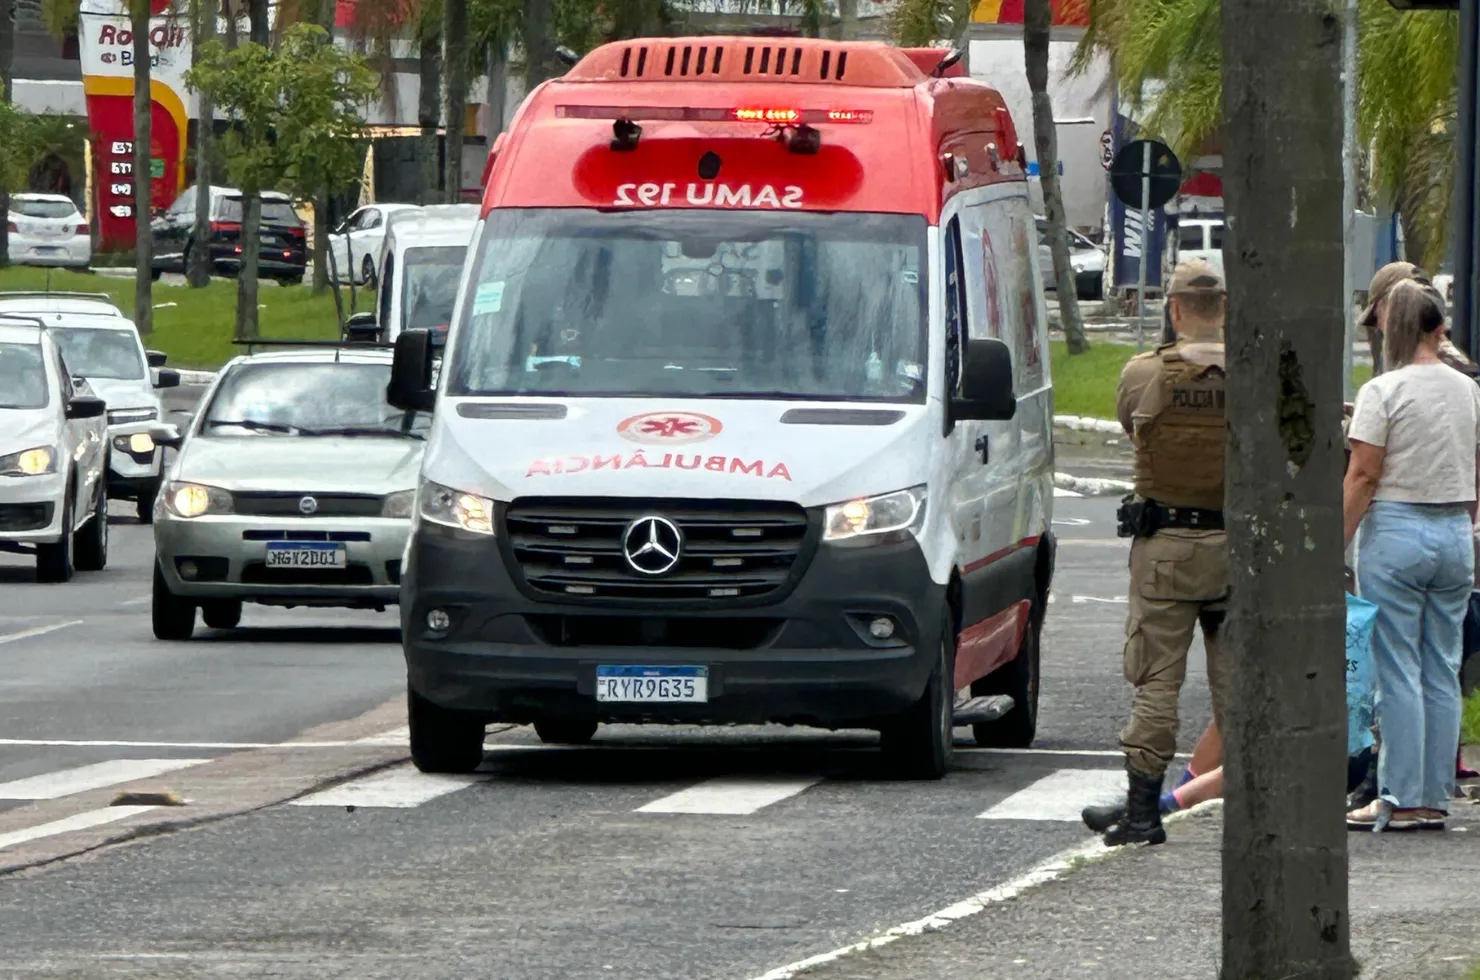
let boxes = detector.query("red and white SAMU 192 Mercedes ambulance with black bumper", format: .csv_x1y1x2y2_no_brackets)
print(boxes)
389,37,1055,779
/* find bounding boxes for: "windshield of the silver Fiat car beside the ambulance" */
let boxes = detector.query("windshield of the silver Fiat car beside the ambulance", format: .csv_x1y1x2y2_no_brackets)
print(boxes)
201,361,429,438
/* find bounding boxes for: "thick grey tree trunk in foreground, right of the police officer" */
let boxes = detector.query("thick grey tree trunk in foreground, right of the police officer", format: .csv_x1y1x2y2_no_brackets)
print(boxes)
1221,0,1354,980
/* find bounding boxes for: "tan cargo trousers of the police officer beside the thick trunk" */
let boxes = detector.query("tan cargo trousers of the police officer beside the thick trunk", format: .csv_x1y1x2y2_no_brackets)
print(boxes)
1120,530,1231,777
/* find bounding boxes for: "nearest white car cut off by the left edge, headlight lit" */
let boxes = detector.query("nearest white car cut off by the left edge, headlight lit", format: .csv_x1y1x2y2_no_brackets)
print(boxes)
0,315,108,582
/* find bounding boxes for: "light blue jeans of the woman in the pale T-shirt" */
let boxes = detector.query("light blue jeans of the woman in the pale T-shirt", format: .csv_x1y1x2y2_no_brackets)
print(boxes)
1357,500,1474,811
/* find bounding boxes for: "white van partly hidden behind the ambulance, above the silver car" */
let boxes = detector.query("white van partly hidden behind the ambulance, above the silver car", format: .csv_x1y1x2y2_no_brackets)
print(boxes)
345,204,478,342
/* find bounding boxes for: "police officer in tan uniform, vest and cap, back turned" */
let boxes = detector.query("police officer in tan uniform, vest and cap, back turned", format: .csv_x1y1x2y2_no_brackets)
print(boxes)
1083,259,1228,845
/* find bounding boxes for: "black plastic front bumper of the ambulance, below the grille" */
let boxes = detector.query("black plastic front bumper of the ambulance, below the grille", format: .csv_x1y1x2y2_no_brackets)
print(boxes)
401,524,946,728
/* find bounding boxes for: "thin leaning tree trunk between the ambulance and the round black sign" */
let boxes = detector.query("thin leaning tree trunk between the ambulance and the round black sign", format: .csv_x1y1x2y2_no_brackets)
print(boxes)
1023,0,1089,354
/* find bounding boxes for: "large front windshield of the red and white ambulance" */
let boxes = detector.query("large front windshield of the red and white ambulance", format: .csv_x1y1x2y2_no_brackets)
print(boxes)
448,209,926,401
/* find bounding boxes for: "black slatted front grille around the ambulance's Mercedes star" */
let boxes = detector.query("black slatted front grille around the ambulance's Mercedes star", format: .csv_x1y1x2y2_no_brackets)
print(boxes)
505,497,807,603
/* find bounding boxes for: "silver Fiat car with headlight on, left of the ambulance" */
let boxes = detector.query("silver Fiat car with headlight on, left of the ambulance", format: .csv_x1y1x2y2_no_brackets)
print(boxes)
154,348,429,640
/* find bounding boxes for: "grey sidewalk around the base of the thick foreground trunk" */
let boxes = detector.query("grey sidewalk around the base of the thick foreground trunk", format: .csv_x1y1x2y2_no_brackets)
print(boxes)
796,769,1480,980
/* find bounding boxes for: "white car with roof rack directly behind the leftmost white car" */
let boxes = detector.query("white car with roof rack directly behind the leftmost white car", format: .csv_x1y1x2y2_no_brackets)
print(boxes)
0,292,181,524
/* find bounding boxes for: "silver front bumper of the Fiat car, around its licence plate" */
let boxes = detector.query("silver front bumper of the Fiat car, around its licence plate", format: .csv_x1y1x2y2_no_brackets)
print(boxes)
154,515,410,607
